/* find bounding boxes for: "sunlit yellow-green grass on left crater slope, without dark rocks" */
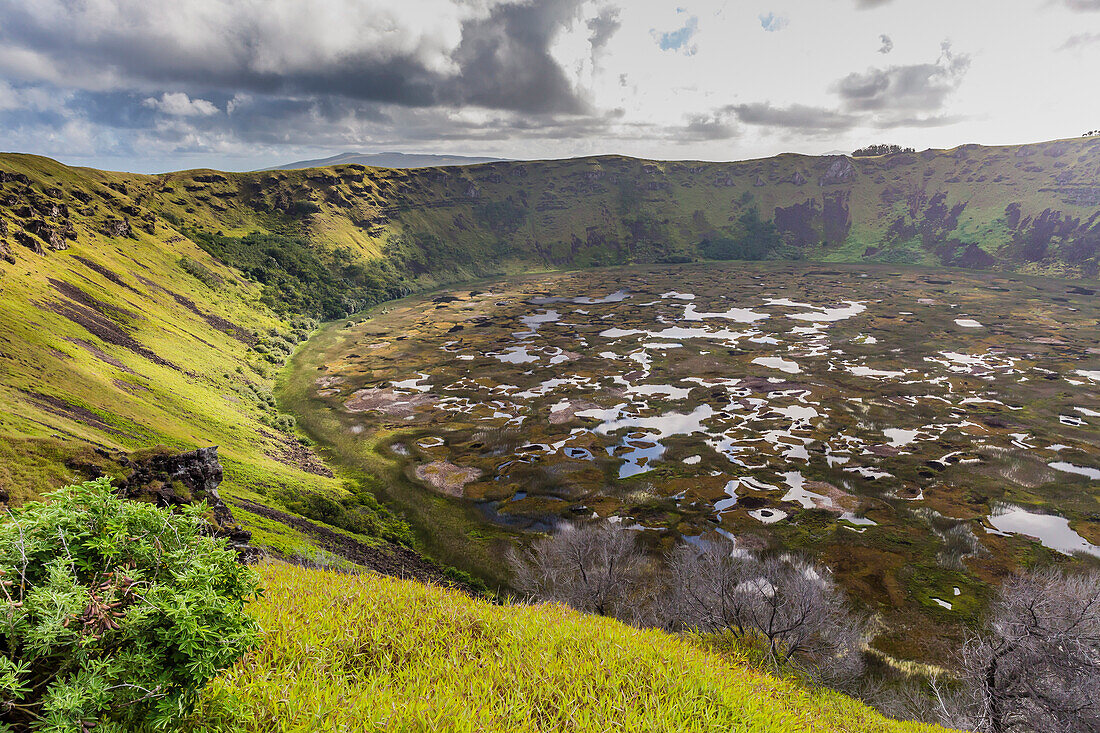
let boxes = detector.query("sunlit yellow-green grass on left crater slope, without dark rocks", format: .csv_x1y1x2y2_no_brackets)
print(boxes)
0,155,380,553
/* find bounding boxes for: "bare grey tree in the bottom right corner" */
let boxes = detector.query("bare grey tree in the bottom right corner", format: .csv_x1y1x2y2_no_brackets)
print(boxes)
933,569,1100,733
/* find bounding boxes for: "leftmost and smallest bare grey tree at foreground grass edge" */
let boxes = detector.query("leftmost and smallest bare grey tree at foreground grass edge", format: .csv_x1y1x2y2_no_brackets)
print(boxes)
508,522,646,620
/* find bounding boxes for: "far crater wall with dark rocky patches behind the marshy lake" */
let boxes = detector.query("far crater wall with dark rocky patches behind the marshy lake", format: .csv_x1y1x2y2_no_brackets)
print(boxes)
150,132,1100,278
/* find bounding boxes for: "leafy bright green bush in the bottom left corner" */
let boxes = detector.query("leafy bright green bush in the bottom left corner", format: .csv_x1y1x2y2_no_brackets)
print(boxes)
0,479,259,733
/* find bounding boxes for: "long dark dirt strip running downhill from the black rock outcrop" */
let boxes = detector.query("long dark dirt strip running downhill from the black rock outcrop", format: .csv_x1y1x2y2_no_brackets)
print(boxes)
233,499,476,595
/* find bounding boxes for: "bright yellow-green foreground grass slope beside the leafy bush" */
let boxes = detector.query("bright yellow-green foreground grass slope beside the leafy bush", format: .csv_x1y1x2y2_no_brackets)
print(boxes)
195,556,941,733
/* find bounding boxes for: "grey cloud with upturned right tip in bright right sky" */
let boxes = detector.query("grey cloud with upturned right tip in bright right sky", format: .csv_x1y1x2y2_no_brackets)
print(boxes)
833,43,970,113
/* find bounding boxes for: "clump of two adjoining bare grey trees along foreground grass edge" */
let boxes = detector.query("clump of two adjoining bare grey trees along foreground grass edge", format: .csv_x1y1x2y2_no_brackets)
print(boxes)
509,523,867,688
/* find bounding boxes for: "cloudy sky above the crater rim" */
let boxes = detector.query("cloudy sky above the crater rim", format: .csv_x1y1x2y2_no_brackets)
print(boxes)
0,0,1100,173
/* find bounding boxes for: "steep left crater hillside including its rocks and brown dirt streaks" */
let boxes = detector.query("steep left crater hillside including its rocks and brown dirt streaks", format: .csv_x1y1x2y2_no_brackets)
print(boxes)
0,156,422,572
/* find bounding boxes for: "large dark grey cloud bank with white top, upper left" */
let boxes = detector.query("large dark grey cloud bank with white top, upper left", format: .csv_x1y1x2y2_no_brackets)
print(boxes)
0,0,584,113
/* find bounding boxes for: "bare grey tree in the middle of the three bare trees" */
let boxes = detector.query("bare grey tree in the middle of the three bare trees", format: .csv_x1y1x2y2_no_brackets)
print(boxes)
662,541,866,686
